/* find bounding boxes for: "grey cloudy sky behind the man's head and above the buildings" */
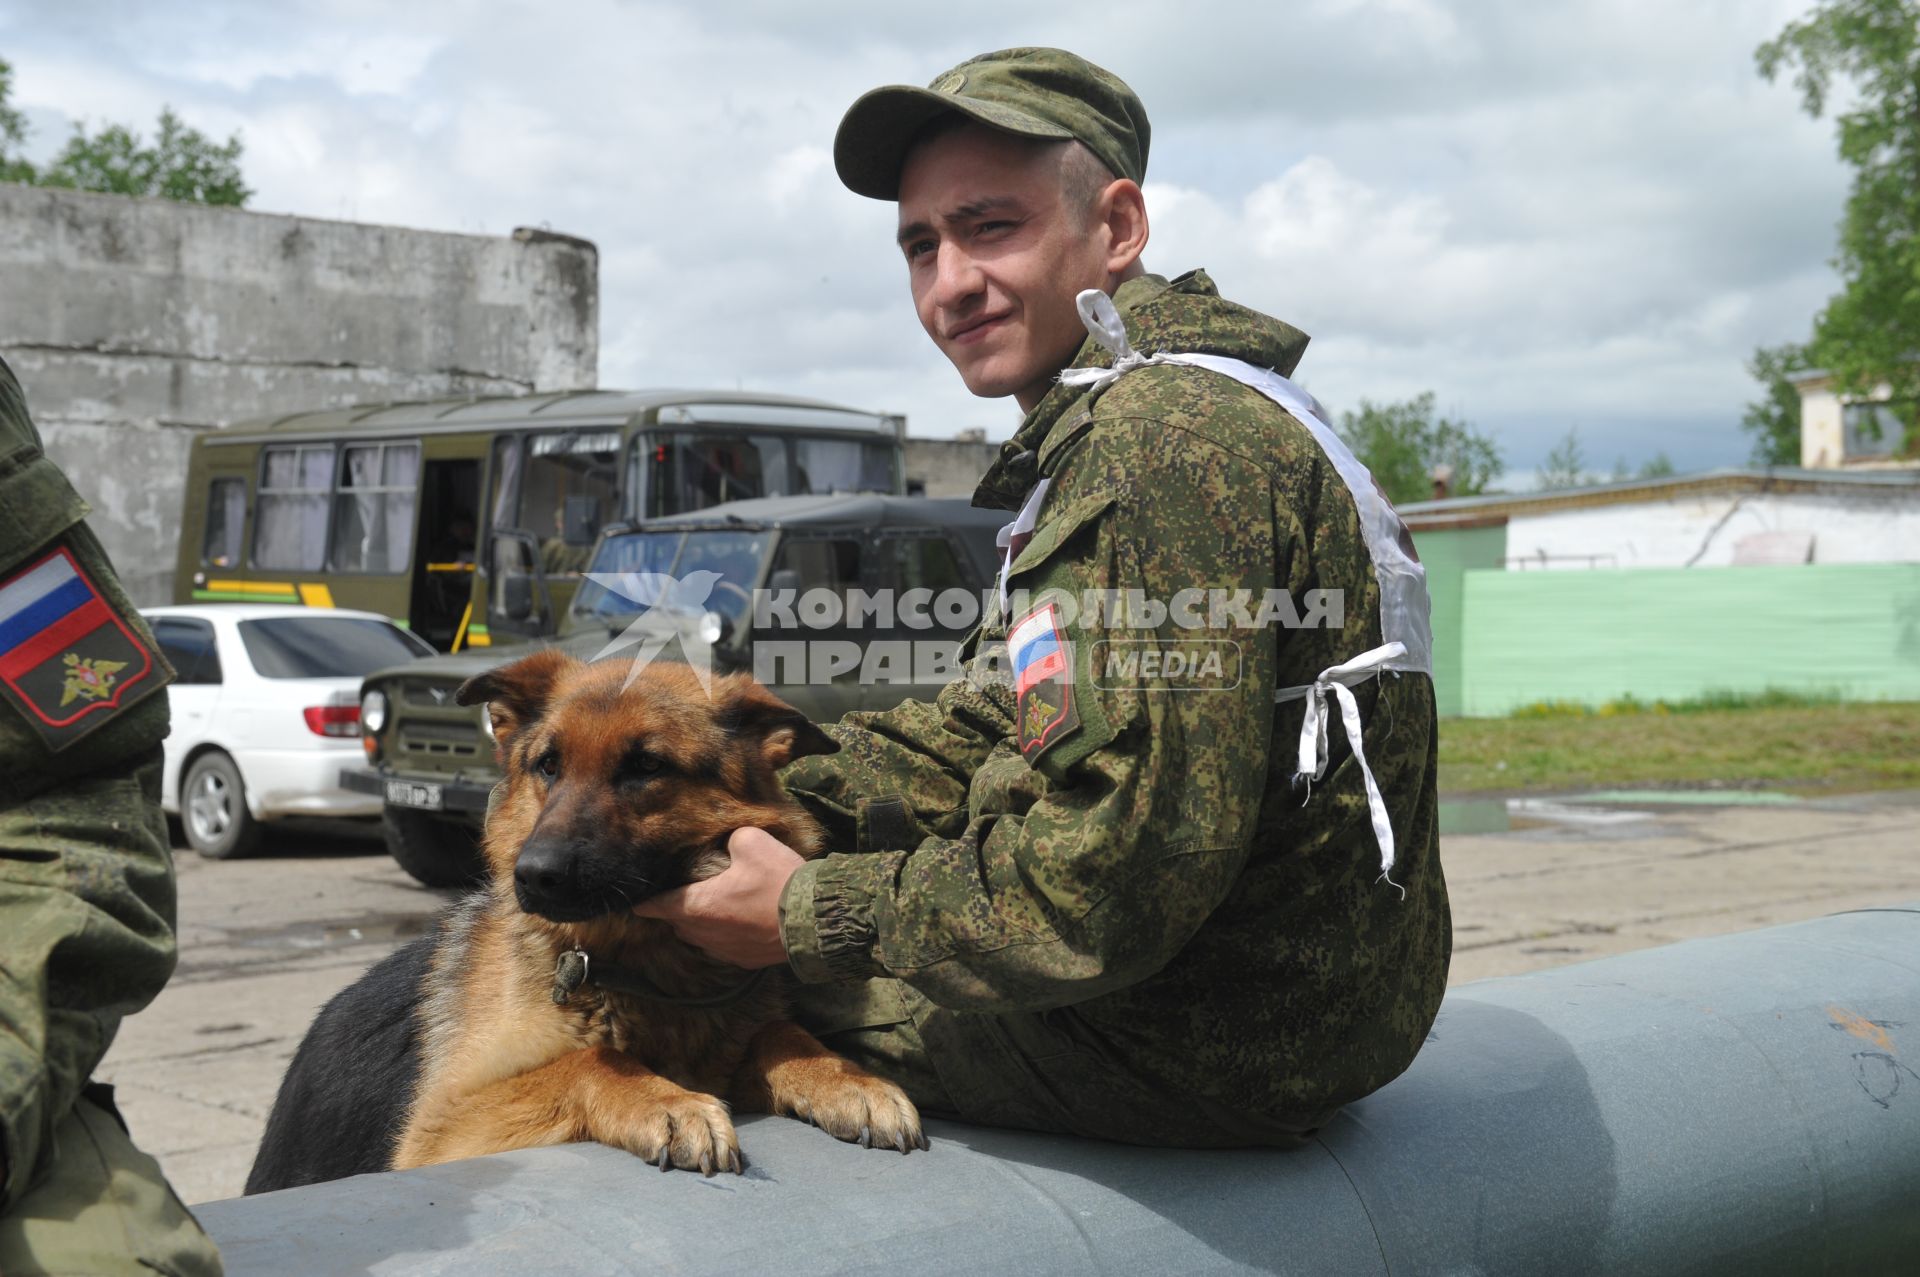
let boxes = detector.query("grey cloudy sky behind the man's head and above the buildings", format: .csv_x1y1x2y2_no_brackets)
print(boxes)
0,0,1847,482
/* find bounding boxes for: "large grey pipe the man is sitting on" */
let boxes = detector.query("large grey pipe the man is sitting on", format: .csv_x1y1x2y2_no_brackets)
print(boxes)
198,908,1920,1275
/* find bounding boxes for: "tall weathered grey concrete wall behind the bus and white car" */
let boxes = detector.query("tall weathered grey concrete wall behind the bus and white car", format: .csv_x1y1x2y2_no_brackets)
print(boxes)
0,184,599,603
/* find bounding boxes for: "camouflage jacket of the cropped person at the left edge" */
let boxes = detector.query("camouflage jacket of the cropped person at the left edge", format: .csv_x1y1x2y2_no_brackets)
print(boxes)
0,363,175,1214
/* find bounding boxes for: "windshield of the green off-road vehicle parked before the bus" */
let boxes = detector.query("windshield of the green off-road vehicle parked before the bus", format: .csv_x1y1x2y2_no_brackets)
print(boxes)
572,528,772,626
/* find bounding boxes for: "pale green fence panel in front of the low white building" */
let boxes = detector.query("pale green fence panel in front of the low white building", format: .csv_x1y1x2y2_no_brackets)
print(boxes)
1436,563,1920,716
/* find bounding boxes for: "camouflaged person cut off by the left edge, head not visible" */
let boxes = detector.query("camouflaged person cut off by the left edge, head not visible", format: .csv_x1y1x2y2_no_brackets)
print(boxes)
0,361,221,1277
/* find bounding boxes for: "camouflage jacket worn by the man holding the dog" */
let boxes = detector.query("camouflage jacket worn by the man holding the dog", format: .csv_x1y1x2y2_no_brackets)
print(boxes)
781,271,1452,1127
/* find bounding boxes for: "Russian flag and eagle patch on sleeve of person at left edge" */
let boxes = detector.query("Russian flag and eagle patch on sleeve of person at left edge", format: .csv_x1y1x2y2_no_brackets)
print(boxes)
0,545,167,751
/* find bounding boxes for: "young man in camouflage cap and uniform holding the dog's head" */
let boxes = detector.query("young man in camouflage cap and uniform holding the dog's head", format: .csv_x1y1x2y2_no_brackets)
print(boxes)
641,48,1452,1146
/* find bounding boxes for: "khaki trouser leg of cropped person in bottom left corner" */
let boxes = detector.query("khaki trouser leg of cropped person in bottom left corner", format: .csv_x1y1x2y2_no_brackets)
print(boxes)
0,1087,221,1277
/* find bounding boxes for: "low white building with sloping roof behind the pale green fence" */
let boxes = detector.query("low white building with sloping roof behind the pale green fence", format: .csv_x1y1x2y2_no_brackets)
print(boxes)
1400,467,1920,570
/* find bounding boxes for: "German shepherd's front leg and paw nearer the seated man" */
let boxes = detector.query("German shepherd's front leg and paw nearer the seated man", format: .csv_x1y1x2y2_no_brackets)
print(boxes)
733,1022,927,1152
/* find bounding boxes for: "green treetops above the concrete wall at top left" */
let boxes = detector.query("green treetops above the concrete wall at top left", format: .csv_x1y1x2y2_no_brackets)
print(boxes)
0,61,253,207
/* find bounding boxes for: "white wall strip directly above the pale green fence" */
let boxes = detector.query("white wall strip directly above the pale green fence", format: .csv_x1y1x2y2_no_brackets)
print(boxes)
1507,484,1920,570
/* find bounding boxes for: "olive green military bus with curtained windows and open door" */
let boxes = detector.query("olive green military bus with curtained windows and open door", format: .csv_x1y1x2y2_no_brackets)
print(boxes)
175,390,906,651
